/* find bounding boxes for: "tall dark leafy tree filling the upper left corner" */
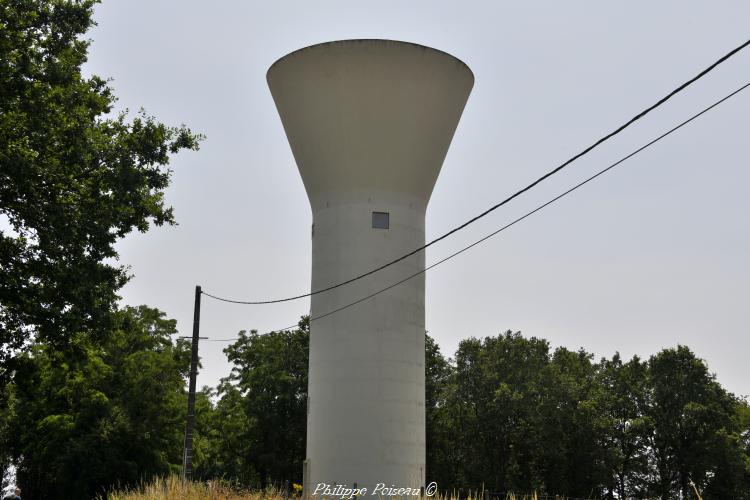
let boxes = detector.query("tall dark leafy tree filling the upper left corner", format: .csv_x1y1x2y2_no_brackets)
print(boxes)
0,0,201,378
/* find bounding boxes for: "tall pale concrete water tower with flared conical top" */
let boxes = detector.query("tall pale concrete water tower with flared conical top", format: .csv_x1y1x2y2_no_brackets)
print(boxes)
267,40,474,495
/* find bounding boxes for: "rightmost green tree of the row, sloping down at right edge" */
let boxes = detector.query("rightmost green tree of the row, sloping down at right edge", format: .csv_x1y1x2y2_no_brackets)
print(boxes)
648,346,750,500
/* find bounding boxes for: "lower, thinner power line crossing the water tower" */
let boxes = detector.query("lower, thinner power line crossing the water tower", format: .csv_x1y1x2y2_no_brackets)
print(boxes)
203,82,750,342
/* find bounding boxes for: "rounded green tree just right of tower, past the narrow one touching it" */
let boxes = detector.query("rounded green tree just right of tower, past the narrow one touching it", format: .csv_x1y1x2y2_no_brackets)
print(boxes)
439,331,549,491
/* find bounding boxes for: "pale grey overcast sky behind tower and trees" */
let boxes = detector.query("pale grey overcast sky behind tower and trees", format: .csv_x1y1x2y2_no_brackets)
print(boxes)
86,0,750,394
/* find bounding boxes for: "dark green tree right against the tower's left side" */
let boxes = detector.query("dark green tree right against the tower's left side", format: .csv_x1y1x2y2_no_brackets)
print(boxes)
224,317,310,488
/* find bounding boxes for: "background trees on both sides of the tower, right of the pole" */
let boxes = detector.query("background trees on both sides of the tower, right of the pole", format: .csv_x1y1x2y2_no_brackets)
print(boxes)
187,321,750,499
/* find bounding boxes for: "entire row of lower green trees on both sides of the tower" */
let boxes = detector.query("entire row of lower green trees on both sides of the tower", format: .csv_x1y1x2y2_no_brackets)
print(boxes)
0,306,750,499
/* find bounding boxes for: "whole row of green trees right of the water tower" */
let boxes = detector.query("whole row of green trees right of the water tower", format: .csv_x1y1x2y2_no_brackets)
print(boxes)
426,331,750,499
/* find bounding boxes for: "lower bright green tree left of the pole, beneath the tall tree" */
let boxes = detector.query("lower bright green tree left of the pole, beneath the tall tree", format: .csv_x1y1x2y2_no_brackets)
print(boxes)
8,306,190,499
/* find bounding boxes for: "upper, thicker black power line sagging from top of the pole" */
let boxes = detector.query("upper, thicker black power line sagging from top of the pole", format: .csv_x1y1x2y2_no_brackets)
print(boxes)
203,40,750,305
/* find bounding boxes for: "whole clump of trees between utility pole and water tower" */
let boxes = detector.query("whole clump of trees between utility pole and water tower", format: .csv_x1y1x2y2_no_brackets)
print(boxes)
196,317,310,489
